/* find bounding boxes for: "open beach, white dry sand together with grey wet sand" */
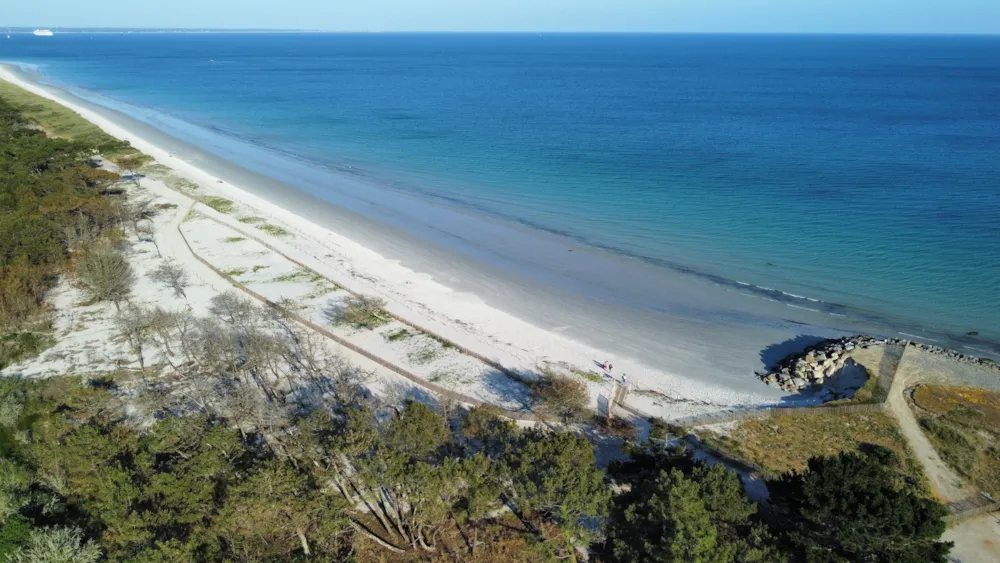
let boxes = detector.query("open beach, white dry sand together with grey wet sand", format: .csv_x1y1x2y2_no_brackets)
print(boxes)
3,64,996,411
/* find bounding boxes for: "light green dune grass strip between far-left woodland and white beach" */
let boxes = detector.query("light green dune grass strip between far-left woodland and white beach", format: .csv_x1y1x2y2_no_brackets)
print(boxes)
0,80,138,158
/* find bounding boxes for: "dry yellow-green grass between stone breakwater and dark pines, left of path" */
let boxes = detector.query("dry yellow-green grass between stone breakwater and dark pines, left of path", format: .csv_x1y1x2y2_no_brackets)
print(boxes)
706,412,932,497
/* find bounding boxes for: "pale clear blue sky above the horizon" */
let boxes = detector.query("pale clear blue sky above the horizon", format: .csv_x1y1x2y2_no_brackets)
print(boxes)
0,0,1000,33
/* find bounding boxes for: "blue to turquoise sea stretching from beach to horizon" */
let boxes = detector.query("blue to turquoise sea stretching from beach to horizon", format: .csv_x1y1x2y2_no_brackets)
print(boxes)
0,34,1000,341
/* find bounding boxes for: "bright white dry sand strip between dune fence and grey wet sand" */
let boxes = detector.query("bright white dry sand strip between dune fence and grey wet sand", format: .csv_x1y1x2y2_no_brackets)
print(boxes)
0,64,804,416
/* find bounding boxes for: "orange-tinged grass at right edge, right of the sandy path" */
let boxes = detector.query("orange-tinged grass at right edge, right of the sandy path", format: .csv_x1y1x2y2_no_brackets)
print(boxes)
913,385,1000,497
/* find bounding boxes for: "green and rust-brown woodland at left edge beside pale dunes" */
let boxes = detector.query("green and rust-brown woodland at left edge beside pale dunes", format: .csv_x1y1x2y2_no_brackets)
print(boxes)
0,94,132,368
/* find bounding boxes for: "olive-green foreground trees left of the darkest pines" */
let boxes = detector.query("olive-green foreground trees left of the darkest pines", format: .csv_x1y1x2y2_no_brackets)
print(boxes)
0,378,610,561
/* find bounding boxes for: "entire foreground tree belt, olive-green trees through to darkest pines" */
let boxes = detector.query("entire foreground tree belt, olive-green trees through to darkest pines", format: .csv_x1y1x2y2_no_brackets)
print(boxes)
0,378,949,563
